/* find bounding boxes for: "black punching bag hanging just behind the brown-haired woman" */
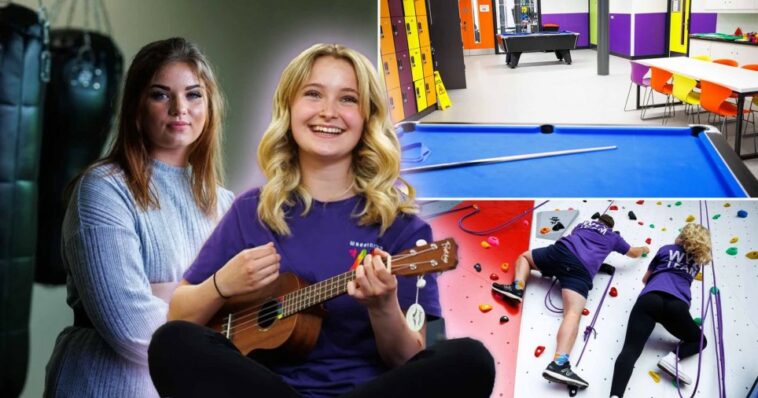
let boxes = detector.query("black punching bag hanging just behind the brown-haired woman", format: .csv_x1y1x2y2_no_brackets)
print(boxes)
35,28,123,284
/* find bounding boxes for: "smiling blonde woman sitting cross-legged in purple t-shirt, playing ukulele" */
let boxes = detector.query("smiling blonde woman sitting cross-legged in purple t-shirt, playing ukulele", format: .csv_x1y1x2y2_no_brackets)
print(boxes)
150,44,494,397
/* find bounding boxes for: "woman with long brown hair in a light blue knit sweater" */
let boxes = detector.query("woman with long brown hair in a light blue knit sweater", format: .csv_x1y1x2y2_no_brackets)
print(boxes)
45,38,233,397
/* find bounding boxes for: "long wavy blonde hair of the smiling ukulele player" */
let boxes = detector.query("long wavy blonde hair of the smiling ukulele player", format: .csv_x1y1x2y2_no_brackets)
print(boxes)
258,44,417,235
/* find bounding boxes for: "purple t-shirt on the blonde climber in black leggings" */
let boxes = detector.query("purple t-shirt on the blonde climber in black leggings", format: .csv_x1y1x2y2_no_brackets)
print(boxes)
640,245,700,305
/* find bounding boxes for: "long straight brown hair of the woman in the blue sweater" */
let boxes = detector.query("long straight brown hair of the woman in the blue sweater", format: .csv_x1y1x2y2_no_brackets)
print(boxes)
104,38,224,215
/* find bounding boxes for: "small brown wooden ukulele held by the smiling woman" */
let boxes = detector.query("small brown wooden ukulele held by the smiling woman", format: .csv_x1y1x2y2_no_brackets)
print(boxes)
208,238,458,358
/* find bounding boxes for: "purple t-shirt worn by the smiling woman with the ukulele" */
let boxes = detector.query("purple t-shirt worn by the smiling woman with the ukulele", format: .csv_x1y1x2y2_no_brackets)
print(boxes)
184,189,441,396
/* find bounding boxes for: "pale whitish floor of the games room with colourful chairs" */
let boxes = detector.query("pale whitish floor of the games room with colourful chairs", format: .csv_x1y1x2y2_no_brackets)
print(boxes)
422,50,758,176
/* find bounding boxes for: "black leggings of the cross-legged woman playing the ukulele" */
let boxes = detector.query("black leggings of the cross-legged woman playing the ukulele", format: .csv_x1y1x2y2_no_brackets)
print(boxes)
148,321,495,398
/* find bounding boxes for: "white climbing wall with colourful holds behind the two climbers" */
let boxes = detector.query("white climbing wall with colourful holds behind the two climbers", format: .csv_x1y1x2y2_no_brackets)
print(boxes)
512,200,758,398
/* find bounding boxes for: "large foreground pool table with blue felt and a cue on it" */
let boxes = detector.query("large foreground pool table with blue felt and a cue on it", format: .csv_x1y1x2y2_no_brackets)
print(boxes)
396,122,758,199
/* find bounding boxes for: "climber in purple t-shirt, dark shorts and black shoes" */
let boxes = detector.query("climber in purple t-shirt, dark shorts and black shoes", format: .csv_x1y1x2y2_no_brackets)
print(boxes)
492,214,650,388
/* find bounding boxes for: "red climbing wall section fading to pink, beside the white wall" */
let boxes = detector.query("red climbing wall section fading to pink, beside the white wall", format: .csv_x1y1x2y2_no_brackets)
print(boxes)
429,201,534,398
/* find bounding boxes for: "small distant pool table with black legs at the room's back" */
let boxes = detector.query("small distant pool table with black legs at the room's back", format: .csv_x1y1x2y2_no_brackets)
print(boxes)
497,31,579,69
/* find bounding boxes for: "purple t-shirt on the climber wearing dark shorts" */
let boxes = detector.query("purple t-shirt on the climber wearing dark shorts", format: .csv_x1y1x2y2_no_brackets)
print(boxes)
558,220,631,278
